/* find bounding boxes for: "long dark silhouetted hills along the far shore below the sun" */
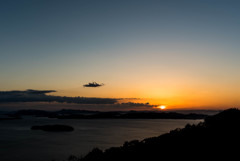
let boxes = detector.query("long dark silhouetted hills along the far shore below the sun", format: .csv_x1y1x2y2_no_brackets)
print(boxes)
11,110,207,119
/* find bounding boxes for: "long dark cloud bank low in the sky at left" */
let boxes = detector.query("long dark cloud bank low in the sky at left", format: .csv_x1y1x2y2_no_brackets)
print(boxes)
0,89,118,104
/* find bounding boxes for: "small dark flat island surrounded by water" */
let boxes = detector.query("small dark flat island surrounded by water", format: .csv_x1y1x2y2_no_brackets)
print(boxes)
31,125,74,132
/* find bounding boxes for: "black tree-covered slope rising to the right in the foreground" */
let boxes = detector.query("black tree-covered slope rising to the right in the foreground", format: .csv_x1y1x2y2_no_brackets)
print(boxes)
69,109,240,161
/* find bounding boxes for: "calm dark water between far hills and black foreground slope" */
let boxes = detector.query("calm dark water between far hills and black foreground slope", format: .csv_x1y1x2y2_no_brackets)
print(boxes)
0,117,202,161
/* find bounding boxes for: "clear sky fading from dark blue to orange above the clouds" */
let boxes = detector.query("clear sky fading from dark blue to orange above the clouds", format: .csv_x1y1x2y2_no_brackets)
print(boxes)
0,0,240,108
